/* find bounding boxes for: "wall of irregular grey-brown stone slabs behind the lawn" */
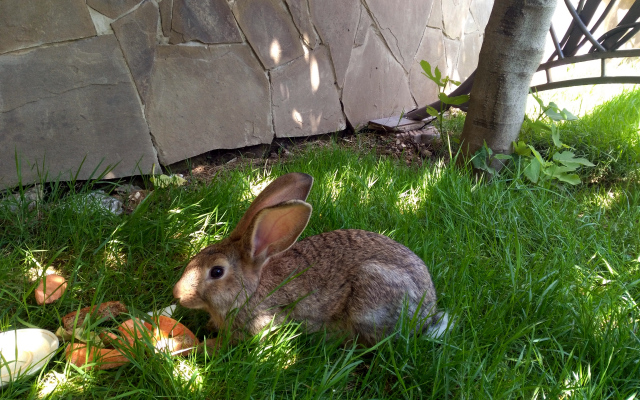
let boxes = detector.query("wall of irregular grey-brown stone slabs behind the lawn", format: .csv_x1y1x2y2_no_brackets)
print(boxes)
0,0,493,189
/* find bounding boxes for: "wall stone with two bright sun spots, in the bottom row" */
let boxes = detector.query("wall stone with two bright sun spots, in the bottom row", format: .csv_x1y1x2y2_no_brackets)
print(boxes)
271,46,346,137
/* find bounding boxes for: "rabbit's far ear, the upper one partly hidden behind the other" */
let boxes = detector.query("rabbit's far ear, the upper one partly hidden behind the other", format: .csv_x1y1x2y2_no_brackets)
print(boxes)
229,172,313,240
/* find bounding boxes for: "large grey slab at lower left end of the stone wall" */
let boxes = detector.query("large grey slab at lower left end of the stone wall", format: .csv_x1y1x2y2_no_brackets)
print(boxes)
0,35,157,187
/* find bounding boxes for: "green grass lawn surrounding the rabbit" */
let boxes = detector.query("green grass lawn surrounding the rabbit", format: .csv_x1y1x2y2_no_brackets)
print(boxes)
0,90,640,399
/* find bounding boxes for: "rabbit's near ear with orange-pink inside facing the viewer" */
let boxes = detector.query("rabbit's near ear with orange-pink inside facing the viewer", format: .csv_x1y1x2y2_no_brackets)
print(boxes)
245,200,312,265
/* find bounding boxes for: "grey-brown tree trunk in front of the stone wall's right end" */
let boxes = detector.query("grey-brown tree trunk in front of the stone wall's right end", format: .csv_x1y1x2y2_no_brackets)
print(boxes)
461,0,556,169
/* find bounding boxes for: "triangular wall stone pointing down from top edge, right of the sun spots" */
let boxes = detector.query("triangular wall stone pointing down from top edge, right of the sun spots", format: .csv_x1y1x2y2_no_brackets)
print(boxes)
309,0,360,88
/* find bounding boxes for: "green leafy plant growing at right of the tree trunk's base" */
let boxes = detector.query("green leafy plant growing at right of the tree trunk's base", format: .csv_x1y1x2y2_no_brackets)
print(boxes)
472,93,594,185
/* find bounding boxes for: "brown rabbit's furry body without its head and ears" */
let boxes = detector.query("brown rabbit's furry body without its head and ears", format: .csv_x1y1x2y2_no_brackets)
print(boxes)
244,229,439,345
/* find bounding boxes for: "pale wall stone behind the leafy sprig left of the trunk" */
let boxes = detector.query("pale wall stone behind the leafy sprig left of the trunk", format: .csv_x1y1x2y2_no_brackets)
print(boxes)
409,28,447,107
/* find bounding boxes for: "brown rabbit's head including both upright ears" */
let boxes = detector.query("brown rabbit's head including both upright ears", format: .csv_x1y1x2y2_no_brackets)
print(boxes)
173,173,313,327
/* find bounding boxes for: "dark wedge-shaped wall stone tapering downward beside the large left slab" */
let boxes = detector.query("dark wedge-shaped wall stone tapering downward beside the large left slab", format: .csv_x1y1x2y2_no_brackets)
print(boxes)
111,1,158,103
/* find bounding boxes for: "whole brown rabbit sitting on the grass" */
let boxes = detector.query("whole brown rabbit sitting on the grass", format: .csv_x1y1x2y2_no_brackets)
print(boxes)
173,173,448,346
